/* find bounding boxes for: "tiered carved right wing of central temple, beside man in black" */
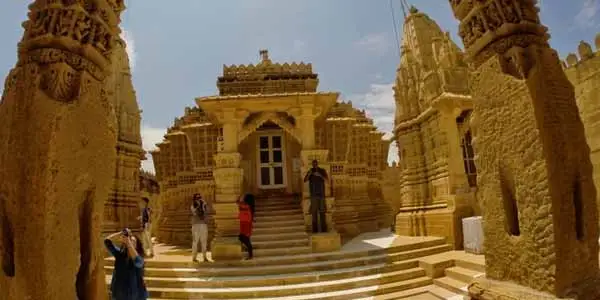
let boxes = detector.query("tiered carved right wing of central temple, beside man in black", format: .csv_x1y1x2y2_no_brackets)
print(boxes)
315,102,392,239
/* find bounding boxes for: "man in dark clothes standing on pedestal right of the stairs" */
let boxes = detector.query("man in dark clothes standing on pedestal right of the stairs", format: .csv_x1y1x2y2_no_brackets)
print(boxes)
304,160,328,233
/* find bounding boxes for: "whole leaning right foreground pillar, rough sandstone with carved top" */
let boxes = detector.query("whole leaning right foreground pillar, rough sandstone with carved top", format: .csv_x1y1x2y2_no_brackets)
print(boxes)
450,0,600,299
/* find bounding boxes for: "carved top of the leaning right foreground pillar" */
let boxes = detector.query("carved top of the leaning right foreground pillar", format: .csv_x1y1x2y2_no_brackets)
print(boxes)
450,0,548,71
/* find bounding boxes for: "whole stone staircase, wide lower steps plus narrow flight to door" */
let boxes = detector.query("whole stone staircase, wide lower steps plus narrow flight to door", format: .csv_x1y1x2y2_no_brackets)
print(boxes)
105,198,488,300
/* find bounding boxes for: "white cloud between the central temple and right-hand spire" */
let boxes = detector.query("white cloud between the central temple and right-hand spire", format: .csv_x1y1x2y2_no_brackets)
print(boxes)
350,83,398,163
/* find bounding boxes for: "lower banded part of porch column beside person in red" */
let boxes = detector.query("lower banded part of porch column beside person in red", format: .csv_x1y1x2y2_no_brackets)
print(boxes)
211,152,243,260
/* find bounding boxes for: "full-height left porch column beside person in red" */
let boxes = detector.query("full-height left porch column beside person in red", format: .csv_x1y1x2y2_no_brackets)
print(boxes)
211,110,243,260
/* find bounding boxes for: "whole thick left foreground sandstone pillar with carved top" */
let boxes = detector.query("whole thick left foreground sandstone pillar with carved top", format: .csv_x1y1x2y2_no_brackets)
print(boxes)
0,0,124,300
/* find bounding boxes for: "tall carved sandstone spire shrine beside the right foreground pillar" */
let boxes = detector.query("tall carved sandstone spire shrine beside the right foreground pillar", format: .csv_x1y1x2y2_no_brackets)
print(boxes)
392,7,473,249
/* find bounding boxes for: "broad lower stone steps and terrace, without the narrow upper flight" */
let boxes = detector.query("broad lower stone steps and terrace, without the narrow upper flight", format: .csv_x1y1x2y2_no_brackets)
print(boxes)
105,231,484,300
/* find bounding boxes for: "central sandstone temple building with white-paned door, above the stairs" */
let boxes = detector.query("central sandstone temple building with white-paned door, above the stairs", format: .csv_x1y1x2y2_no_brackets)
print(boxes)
152,50,391,255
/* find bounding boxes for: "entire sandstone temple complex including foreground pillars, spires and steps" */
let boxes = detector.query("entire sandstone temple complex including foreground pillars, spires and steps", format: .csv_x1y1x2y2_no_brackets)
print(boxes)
0,0,600,300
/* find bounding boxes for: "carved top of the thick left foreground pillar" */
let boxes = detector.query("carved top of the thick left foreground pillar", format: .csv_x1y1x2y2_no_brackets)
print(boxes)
12,0,125,102
